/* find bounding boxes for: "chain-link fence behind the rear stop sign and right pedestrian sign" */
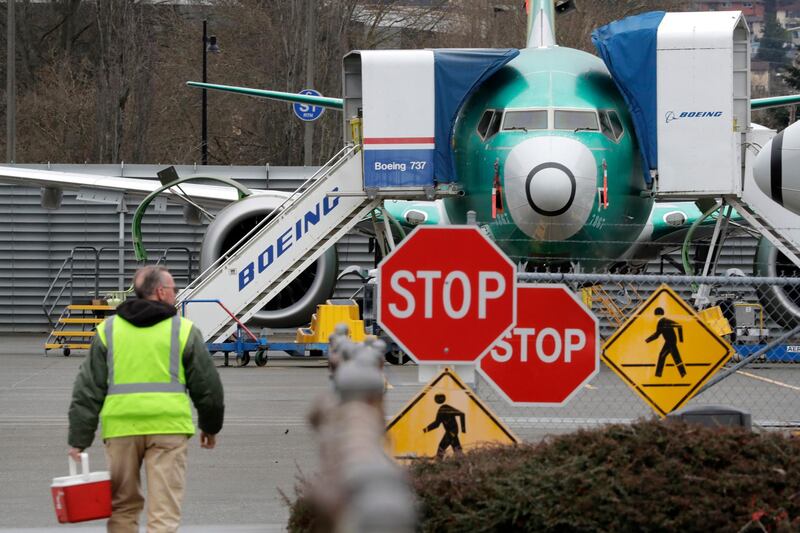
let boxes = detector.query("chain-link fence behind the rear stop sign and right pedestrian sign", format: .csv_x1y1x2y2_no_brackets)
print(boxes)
466,272,800,440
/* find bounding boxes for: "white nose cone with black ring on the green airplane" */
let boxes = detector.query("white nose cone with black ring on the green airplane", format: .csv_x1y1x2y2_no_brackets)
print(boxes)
503,137,597,241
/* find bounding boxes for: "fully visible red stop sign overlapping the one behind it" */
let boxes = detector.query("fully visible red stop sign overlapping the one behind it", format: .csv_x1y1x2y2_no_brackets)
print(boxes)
377,226,516,363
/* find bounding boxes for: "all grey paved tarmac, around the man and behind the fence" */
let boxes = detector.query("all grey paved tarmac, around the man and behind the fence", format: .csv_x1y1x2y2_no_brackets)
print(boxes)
0,336,800,533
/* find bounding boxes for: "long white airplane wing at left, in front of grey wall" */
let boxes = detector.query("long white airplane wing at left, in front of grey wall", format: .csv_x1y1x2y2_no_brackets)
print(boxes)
0,166,278,208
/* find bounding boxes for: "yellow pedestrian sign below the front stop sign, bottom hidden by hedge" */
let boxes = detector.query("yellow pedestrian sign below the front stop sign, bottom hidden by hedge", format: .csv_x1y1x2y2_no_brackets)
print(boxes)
386,368,519,459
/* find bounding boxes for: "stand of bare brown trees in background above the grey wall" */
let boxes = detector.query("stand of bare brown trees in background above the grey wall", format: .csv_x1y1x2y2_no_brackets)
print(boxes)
0,0,700,165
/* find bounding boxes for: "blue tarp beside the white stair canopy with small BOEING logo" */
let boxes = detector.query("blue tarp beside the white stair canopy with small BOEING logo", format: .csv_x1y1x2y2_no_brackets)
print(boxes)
592,11,665,185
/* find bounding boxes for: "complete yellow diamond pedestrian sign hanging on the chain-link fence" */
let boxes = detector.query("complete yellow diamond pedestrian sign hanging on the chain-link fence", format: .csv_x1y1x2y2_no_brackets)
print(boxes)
602,285,733,416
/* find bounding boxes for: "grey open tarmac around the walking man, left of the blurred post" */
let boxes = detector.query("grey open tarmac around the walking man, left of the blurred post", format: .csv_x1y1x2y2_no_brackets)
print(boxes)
0,337,346,533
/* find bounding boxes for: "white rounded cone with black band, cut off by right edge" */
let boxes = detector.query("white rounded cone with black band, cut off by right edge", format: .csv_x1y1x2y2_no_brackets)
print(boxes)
753,122,800,214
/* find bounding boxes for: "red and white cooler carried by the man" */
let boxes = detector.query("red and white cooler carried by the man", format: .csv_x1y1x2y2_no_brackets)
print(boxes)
50,453,111,524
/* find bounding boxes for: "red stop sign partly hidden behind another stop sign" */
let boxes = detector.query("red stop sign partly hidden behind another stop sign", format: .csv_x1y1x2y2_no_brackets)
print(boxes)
478,284,600,405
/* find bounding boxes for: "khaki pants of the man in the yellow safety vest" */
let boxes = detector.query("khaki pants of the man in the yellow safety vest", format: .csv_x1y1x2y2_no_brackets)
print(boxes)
105,435,189,533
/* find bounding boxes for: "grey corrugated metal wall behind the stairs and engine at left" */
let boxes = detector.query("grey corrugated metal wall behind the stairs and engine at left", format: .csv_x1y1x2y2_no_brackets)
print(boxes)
0,165,372,333
